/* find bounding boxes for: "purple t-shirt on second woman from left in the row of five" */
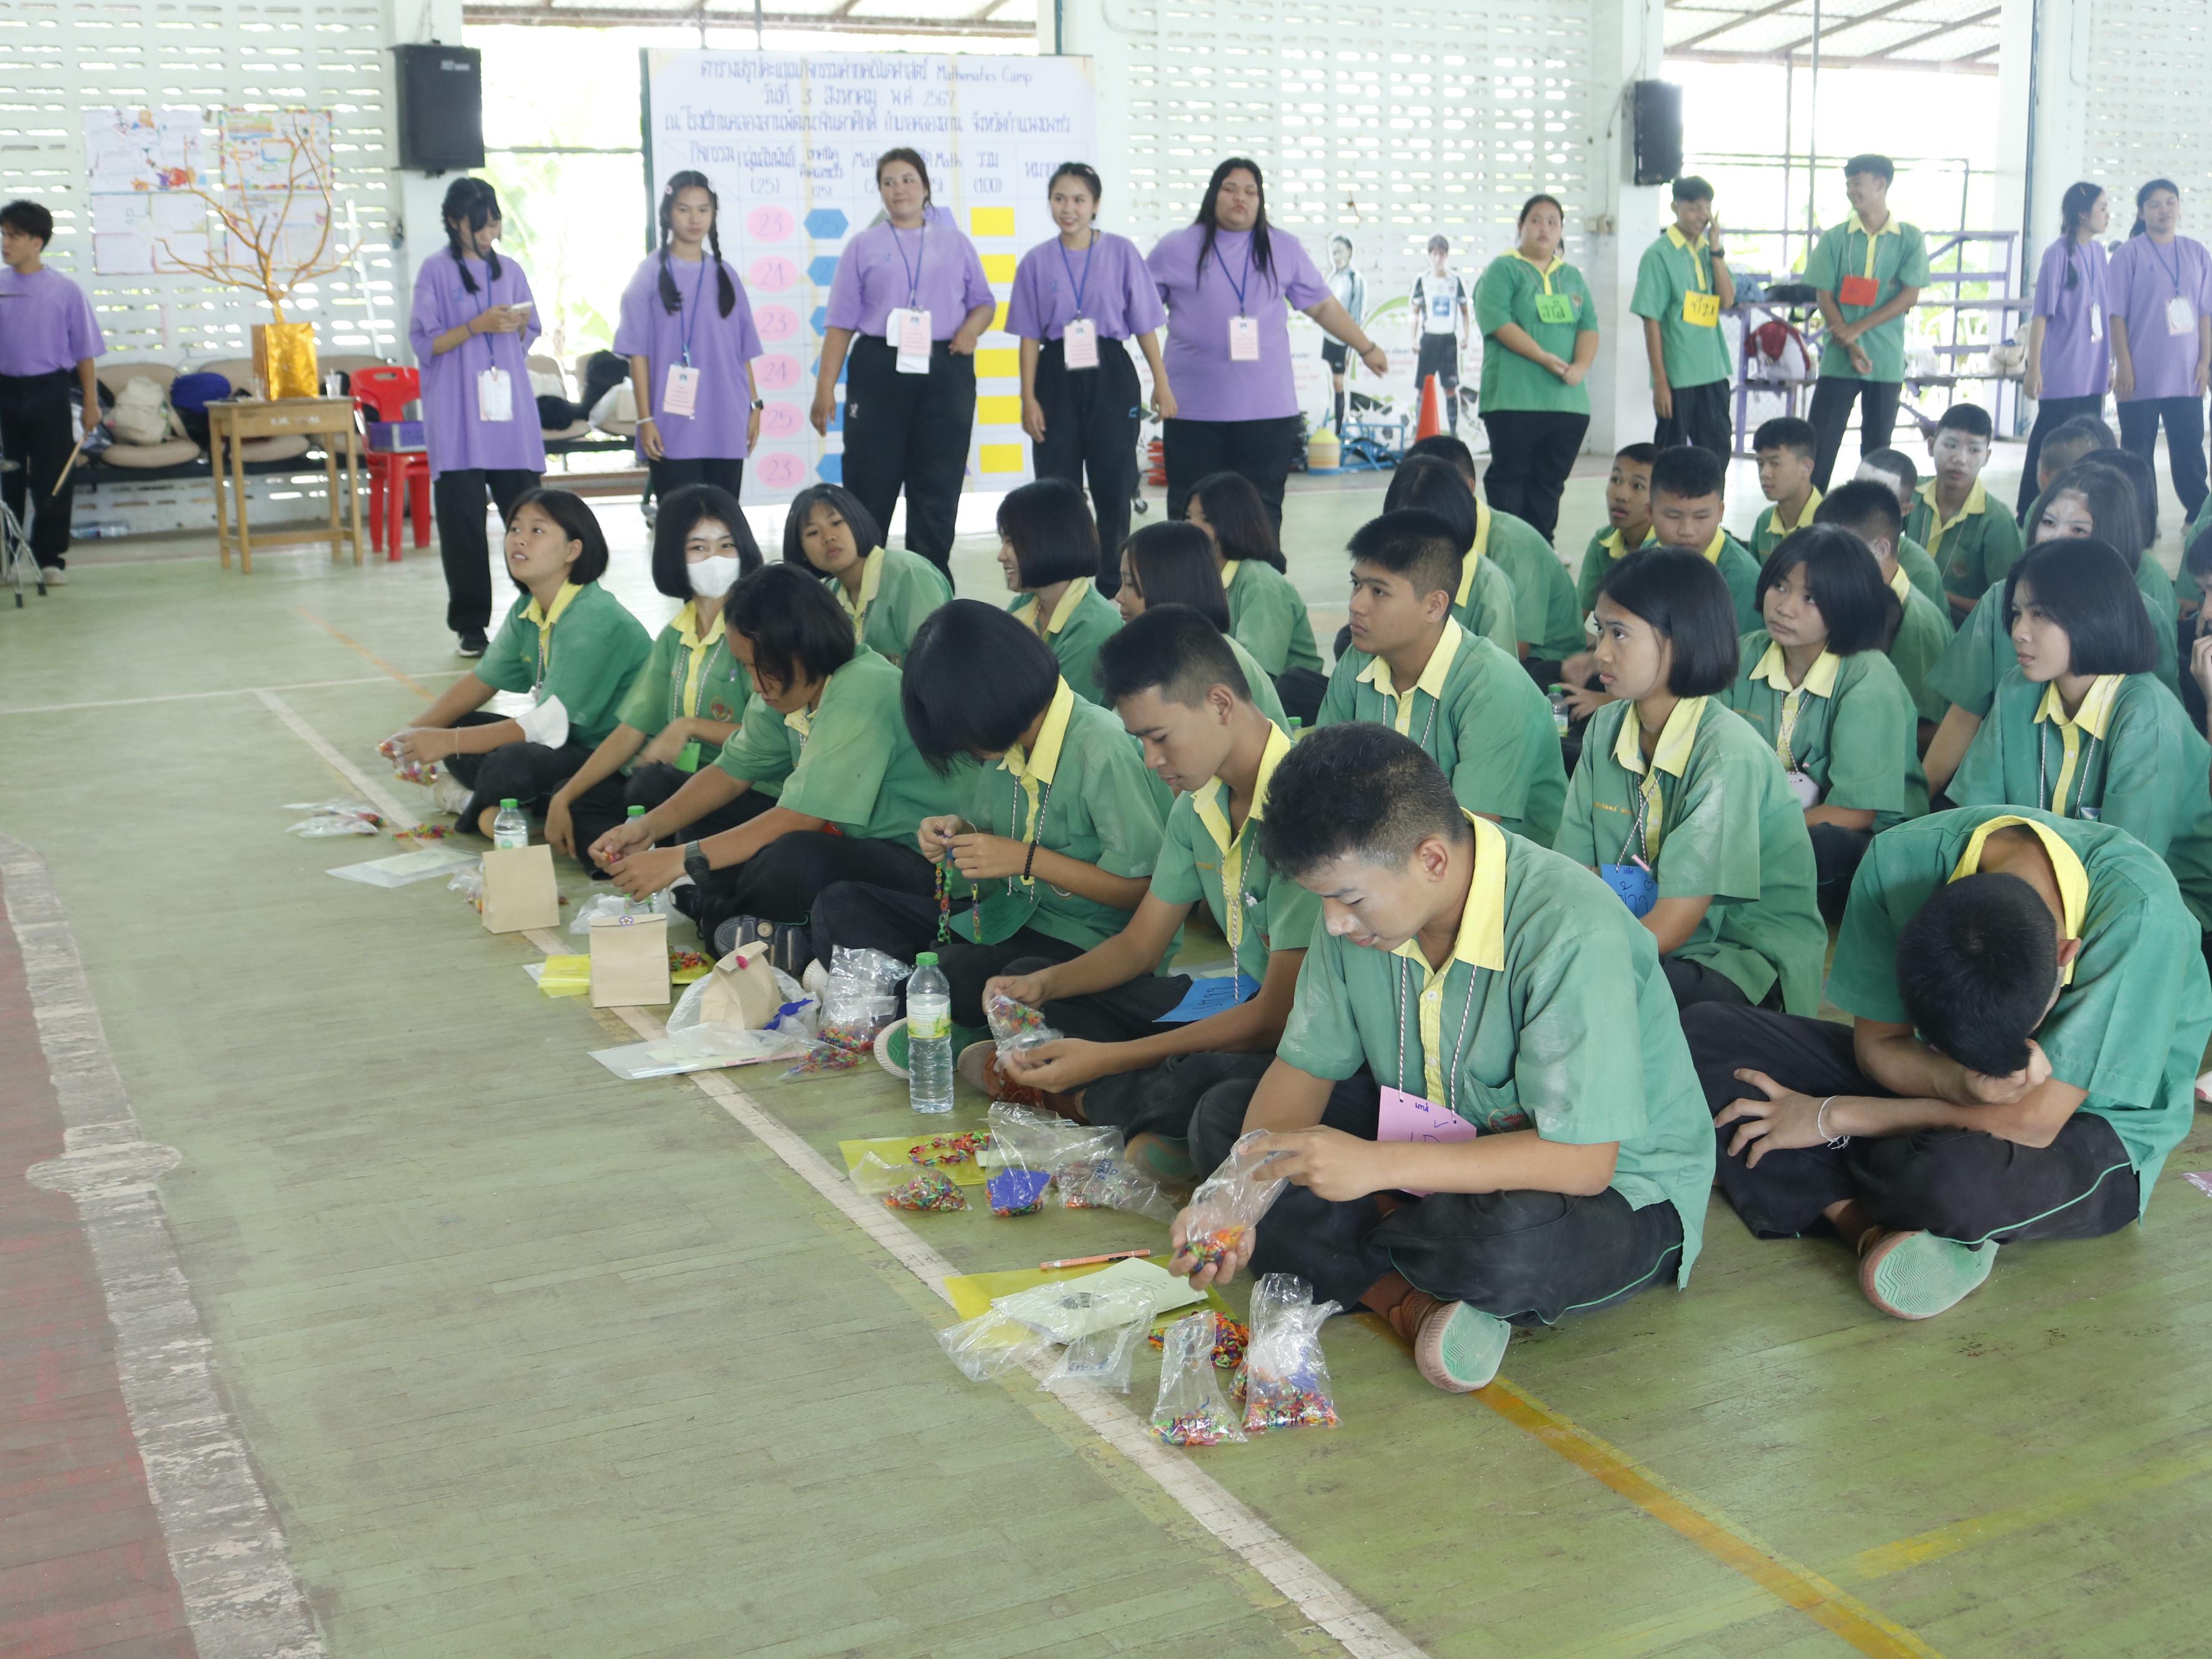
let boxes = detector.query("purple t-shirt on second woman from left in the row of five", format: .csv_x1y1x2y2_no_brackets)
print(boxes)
615,254,761,460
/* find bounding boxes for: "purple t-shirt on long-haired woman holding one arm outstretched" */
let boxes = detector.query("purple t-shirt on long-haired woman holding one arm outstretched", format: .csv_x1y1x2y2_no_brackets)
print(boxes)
1143,225,1330,420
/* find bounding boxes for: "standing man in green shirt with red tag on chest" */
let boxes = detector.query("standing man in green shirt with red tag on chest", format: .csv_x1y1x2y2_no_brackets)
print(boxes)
1805,155,1929,491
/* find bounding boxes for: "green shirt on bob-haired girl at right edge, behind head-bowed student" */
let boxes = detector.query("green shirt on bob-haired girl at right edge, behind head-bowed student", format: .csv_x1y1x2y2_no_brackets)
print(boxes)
1949,668,2212,929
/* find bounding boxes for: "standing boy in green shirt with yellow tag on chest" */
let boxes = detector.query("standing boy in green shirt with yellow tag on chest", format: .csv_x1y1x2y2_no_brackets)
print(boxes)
1628,177,1736,458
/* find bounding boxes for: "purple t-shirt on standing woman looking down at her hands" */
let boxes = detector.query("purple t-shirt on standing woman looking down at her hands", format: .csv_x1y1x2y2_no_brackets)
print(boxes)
407,252,546,478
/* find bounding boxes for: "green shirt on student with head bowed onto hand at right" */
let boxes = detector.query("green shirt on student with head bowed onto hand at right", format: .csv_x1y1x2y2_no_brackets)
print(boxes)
1827,807,2212,1208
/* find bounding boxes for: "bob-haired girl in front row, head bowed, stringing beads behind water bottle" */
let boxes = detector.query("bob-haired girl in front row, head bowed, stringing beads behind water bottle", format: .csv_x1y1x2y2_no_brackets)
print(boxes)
814,602,1161,1077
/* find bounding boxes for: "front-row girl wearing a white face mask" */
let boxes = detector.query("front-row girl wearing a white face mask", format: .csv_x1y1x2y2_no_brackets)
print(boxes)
546,484,774,871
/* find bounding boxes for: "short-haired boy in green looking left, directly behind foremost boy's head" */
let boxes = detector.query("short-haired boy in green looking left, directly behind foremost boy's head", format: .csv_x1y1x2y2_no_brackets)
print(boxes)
1314,511,1566,847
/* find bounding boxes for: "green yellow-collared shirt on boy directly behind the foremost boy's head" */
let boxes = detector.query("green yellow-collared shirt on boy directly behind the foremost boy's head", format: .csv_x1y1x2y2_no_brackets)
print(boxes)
1314,620,1566,847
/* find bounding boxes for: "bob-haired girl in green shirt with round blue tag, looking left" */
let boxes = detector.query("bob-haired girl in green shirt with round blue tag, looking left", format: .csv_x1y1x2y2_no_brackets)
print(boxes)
1553,546,1827,1013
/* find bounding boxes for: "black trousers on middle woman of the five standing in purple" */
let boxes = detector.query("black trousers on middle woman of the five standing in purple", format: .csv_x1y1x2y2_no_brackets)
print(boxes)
845,334,975,579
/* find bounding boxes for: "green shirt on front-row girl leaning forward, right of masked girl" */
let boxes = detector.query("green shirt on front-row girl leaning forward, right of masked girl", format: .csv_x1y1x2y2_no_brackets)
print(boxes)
714,646,975,843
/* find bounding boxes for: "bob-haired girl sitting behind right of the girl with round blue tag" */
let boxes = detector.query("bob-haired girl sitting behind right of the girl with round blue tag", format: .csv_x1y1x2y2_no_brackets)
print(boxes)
1721,524,1929,916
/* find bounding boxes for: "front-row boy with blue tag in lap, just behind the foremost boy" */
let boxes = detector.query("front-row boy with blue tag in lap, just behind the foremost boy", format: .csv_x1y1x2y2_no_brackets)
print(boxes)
982,610,1318,1179
